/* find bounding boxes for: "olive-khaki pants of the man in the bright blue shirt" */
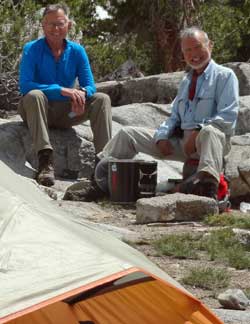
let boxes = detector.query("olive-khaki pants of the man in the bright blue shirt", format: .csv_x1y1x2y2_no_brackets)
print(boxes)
18,90,112,153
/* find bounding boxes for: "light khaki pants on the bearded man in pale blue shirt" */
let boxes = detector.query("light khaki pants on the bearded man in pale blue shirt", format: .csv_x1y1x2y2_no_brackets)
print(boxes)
98,125,230,181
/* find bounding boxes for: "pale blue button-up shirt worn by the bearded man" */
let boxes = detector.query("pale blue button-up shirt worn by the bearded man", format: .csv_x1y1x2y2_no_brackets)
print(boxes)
154,60,239,142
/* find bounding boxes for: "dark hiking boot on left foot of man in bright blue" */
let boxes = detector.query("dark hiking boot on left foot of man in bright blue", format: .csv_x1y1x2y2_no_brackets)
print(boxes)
36,149,55,187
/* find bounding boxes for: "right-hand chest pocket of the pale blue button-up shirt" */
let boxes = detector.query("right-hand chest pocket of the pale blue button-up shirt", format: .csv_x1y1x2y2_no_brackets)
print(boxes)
195,89,216,122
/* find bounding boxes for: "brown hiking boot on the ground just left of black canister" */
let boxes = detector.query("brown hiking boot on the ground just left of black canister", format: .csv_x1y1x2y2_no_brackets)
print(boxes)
63,181,107,202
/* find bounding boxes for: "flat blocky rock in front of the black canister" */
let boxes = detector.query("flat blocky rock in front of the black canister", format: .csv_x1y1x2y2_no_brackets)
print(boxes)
136,193,219,224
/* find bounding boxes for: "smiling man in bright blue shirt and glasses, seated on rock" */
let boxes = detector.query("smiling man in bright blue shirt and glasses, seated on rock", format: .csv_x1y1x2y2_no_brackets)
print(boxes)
18,4,112,186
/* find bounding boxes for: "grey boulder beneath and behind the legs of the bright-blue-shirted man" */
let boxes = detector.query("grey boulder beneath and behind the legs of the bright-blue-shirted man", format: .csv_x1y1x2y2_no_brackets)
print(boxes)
0,119,94,177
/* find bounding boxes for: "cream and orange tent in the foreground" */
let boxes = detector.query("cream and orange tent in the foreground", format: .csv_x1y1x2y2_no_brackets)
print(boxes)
0,162,222,324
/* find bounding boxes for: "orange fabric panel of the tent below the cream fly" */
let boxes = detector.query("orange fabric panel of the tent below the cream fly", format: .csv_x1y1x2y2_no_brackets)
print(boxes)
7,270,222,324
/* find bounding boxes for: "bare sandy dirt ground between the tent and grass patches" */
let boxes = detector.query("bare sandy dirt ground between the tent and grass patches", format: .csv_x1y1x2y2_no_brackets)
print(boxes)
51,185,250,308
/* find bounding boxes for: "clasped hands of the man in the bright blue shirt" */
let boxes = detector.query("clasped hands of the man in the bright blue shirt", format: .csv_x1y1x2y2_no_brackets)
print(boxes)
61,88,86,116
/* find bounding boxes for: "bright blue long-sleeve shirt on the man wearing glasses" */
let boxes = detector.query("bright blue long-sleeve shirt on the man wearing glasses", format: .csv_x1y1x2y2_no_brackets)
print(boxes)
19,38,96,100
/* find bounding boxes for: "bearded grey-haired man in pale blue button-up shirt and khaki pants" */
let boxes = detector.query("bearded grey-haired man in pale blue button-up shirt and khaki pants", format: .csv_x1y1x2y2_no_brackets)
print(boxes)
69,27,239,200
